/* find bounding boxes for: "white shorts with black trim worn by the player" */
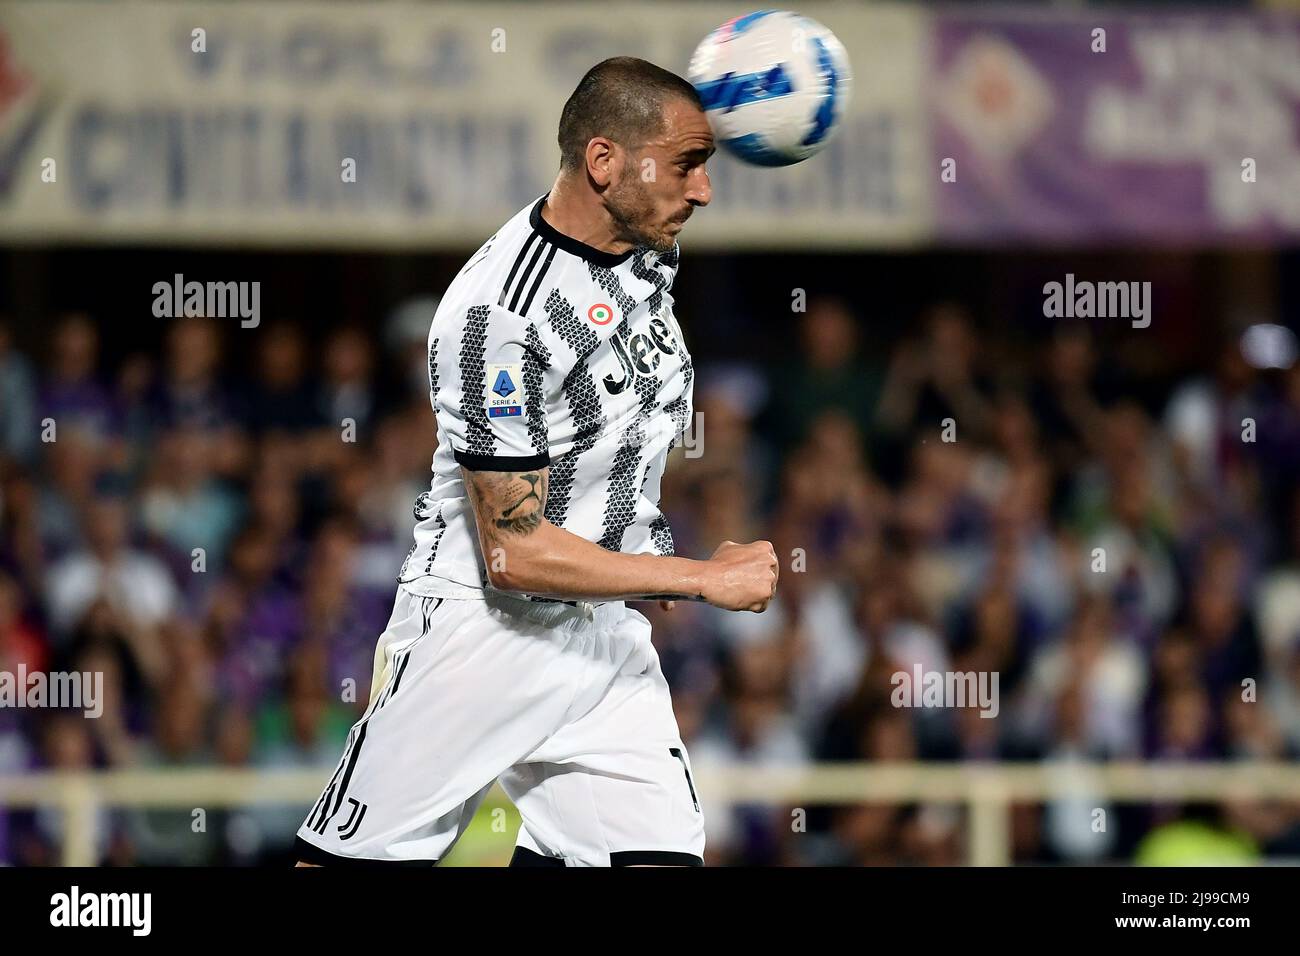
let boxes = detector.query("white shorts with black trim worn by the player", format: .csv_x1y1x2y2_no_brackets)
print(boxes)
296,588,705,866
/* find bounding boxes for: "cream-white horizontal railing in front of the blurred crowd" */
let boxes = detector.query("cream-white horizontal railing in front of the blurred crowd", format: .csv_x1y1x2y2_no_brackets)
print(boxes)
0,762,1300,866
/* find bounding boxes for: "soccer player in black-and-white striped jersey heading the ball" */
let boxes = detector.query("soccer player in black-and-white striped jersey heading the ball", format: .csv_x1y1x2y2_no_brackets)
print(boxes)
296,57,777,866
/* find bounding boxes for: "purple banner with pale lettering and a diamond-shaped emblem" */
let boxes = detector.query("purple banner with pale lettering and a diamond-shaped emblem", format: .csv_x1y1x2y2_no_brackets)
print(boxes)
928,9,1300,243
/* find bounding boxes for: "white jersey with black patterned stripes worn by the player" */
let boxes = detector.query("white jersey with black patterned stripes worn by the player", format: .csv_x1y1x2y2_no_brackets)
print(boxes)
399,196,693,597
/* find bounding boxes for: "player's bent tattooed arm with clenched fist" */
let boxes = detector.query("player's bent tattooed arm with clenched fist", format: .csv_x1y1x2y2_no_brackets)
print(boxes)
462,467,777,611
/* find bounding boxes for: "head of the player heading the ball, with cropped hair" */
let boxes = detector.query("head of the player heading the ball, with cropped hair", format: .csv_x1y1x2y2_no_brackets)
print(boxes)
559,56,714,252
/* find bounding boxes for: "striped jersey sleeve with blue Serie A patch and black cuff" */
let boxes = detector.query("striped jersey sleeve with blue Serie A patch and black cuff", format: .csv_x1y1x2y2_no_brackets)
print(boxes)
430,304,551,471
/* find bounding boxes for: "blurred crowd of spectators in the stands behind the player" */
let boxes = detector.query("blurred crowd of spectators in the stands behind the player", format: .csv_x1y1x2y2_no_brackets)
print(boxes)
0,298,1300,865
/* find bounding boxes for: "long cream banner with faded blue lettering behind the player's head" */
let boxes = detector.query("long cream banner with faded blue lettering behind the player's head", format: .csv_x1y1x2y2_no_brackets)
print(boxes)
0,3,927,248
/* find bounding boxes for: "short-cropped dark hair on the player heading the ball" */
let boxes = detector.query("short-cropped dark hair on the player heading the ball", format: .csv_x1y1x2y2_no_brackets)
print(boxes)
559,56,703,169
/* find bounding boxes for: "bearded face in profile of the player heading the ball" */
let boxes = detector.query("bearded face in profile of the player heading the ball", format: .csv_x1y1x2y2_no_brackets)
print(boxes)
605,99,715,255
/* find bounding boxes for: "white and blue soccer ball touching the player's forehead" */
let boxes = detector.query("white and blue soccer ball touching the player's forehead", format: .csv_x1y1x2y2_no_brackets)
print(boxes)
686,10,853,166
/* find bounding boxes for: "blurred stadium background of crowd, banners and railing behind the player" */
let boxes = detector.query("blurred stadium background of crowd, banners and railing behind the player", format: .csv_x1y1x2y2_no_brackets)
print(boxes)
0,1,1300,865
